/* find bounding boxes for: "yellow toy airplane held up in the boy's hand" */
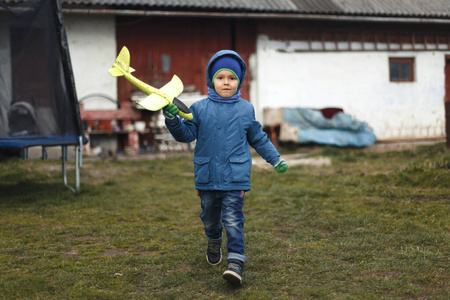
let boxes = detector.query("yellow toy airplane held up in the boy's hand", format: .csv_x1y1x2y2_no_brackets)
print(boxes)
109,46,193,120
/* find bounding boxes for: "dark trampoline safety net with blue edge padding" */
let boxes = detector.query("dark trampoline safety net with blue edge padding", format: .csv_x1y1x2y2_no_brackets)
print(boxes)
0,0,83,150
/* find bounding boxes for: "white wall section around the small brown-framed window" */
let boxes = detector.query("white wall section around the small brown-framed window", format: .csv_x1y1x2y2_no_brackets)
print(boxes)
255,36,450,139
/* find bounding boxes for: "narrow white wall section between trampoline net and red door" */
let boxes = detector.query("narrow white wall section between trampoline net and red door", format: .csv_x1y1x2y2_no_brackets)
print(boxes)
64,13,117,109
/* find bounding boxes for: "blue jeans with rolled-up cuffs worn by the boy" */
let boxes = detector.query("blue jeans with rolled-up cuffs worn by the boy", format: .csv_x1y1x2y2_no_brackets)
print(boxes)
199,191,247,262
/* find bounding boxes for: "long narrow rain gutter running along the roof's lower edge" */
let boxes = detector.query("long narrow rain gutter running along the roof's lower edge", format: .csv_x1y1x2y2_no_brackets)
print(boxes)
62,8,450,24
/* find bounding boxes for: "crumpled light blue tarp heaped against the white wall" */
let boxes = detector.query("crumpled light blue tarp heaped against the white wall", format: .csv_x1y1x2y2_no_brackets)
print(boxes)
283,108,376,147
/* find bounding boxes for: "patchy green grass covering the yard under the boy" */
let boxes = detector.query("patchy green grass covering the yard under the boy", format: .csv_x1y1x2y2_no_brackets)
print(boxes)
0,144,450,299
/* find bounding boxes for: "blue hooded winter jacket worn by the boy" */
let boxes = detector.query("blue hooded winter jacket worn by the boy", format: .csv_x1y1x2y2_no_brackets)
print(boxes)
166,50,280,191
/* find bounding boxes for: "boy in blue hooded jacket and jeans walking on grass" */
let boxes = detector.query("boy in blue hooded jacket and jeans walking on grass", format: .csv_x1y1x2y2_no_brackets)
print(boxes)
163,50,288,285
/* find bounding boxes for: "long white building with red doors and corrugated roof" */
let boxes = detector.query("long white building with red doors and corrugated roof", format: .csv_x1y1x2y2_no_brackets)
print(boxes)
63,0,450,145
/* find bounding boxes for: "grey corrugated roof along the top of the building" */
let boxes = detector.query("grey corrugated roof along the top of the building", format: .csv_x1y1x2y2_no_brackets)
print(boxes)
4,0,450,19
